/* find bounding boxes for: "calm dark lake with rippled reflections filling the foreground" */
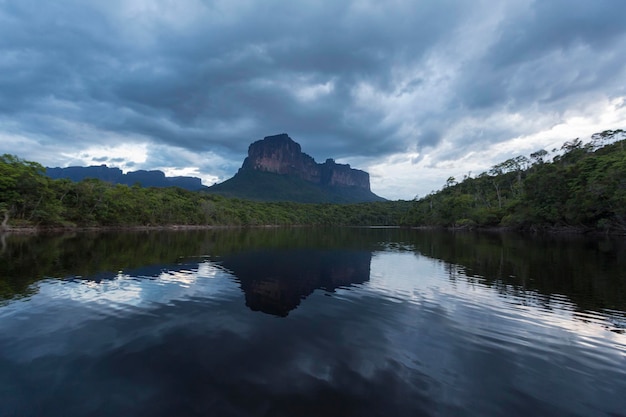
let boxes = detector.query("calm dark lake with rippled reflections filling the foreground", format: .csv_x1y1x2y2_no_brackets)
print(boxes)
0,228,626,417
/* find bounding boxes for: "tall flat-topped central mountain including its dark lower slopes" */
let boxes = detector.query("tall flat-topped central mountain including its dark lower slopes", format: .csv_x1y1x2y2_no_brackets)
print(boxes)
208,133,385,203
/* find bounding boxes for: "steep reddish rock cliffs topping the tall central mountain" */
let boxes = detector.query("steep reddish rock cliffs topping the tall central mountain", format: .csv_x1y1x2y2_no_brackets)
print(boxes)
241,133,370,191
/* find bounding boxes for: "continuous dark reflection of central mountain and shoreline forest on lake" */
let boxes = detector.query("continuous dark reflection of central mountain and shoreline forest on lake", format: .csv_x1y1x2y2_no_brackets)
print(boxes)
0,228,626,318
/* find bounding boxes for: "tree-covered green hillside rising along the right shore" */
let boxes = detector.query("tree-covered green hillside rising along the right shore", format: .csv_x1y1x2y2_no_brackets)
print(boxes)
405,129,626,233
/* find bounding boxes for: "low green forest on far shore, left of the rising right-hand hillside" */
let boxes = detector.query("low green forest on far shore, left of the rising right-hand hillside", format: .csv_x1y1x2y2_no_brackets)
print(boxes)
0,155,411,227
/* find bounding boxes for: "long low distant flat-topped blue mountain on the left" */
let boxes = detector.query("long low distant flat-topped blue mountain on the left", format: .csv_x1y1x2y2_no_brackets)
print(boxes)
46,165,207,191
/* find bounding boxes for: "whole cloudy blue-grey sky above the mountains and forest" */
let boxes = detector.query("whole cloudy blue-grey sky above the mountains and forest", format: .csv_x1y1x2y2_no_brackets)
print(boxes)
0,0,626,200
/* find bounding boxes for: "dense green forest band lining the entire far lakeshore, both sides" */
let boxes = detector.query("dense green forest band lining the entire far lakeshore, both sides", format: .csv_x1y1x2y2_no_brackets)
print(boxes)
0,129,626,233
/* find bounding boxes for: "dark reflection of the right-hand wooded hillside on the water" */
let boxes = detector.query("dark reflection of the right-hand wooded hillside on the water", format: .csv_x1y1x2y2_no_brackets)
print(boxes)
398,233,626,333
